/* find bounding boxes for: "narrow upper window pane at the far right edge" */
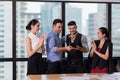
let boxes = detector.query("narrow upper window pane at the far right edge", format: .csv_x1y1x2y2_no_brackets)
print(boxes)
112,4,120,57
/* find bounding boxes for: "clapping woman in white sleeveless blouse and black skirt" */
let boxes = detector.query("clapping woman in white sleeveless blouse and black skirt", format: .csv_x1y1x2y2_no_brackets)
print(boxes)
26,19,45,75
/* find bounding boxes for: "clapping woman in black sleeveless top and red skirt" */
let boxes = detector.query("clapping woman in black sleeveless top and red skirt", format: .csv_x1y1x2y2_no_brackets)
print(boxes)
90,27,112,73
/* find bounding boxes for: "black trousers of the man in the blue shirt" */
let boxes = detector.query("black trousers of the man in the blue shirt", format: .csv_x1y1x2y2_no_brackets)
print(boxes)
47,61,61,74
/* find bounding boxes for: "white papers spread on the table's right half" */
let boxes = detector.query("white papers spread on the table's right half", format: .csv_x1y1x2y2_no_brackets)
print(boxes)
60,73,120,80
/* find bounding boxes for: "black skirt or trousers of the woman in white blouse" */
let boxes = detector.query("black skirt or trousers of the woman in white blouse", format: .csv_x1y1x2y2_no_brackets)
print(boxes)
27,53,42,75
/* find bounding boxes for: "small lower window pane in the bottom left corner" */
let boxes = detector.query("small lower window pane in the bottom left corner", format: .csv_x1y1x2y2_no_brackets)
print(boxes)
0,62,13,80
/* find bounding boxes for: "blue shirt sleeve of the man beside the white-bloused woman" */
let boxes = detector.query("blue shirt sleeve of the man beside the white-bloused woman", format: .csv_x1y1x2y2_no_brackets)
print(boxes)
48,36,57,52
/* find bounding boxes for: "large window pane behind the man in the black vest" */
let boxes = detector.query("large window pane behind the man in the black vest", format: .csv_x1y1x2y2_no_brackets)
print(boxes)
65,3,106,57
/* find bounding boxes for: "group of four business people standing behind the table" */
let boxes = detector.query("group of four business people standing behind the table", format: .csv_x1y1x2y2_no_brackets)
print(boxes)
26,19,112,75
